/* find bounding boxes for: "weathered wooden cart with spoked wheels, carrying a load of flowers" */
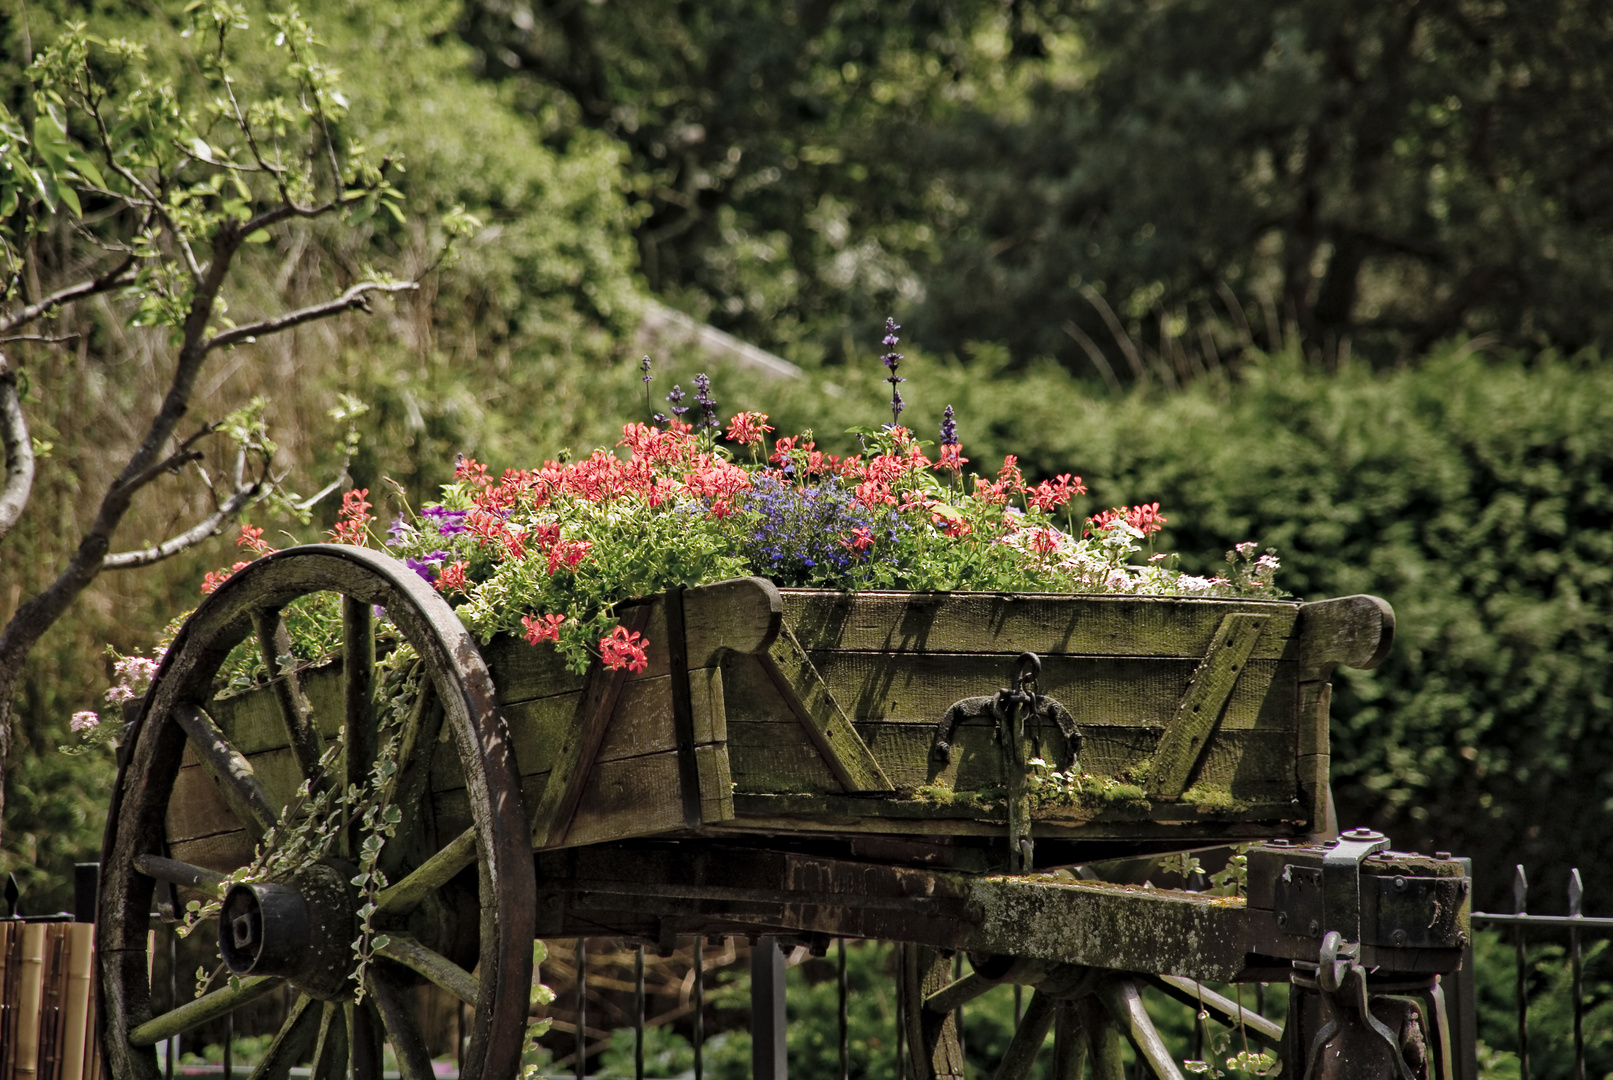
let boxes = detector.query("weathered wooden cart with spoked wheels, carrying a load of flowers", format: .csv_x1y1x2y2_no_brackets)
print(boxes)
98,545,1466,1080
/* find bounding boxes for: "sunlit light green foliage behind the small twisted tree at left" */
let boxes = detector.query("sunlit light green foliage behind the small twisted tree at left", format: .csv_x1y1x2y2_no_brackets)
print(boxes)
0,0,637,911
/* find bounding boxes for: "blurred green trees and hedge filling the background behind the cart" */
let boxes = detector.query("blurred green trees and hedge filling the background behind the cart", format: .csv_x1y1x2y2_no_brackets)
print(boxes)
0,0,1613,992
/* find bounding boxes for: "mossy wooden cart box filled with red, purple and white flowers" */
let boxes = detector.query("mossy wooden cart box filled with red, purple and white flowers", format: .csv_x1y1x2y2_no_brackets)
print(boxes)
138,339,1392,864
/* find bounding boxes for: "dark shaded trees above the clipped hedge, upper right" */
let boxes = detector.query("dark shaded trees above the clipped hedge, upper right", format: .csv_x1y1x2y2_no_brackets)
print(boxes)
461,0,1613,380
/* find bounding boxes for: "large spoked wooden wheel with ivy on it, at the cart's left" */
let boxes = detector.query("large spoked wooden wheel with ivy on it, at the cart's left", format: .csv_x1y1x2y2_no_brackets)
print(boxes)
97,545,536,1080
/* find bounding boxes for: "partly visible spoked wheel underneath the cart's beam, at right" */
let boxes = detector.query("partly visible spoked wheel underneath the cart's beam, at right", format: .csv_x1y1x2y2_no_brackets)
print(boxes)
897,945,1282,1080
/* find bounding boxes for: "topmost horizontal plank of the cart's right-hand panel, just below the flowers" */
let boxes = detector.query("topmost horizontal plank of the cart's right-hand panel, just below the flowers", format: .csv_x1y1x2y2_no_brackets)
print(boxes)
781,588,1298,659
